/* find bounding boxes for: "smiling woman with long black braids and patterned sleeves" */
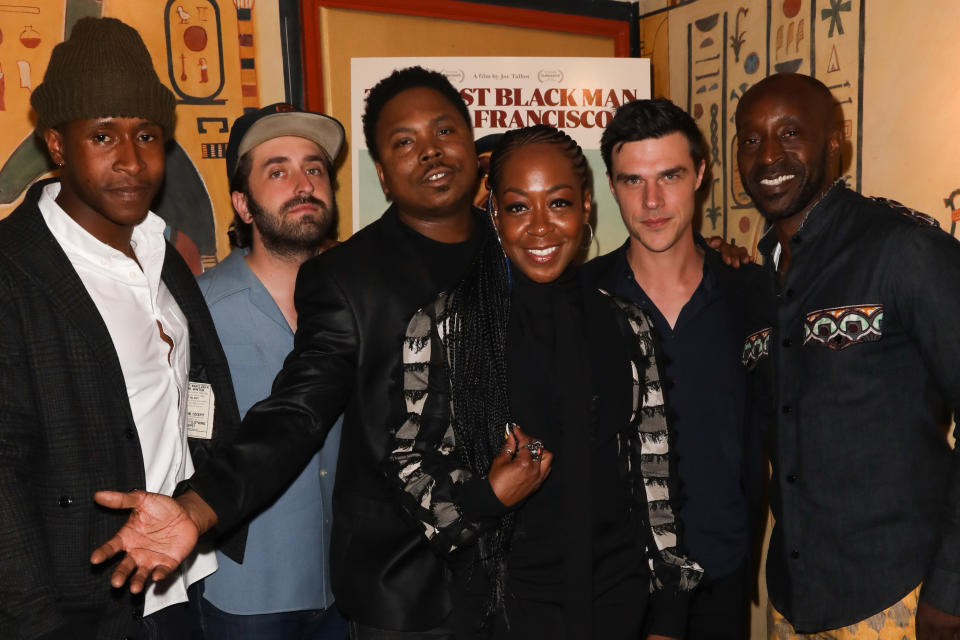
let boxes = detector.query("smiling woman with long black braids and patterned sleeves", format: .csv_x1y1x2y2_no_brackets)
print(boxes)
387,125,702,640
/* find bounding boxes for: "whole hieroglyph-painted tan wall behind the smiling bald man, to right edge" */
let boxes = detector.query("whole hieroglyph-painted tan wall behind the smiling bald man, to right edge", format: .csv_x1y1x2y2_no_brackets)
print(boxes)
640,0,960,255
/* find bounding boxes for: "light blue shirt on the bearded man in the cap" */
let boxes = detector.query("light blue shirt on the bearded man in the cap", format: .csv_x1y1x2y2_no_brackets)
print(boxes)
197,250,341,615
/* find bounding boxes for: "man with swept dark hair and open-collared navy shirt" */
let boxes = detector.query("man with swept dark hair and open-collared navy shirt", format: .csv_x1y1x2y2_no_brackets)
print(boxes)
584,98,763,640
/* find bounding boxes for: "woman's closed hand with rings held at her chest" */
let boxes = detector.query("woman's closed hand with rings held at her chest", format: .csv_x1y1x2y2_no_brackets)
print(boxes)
487,427,553,507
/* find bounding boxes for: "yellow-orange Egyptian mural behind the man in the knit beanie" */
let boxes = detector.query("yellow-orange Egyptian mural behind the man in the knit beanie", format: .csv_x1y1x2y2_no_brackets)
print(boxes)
0,0,284,271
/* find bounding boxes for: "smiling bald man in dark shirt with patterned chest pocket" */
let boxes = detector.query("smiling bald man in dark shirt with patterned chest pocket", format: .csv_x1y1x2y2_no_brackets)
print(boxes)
736,74,960,640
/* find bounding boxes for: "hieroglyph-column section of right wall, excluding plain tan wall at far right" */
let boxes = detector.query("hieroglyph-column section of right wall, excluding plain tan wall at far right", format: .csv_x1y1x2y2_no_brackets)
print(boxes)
670,0,864,254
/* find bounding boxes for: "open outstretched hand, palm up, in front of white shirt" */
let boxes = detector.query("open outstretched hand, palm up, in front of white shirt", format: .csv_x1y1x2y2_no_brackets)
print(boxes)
90,491,200,593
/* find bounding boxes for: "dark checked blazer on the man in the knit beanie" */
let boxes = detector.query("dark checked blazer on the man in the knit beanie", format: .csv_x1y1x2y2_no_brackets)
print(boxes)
0,181,243,640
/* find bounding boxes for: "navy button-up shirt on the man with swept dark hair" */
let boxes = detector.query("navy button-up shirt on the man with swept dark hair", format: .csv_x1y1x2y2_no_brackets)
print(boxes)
612,237,750,580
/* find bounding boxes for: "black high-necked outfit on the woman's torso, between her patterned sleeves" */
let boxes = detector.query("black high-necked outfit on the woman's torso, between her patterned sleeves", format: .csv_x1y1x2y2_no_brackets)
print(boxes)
507,268,646,637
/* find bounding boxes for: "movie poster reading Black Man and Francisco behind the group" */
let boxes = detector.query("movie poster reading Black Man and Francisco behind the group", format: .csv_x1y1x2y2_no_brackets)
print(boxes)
350,57,650,255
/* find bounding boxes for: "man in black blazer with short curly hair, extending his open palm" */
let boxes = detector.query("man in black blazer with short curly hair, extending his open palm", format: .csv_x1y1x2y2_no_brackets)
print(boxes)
94,67,539,640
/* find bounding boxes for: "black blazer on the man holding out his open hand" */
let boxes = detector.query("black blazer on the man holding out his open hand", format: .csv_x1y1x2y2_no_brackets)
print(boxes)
187,208,474,631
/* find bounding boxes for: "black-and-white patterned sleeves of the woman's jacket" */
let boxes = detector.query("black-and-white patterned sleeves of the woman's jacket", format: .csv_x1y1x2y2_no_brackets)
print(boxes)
385,292,703,591
